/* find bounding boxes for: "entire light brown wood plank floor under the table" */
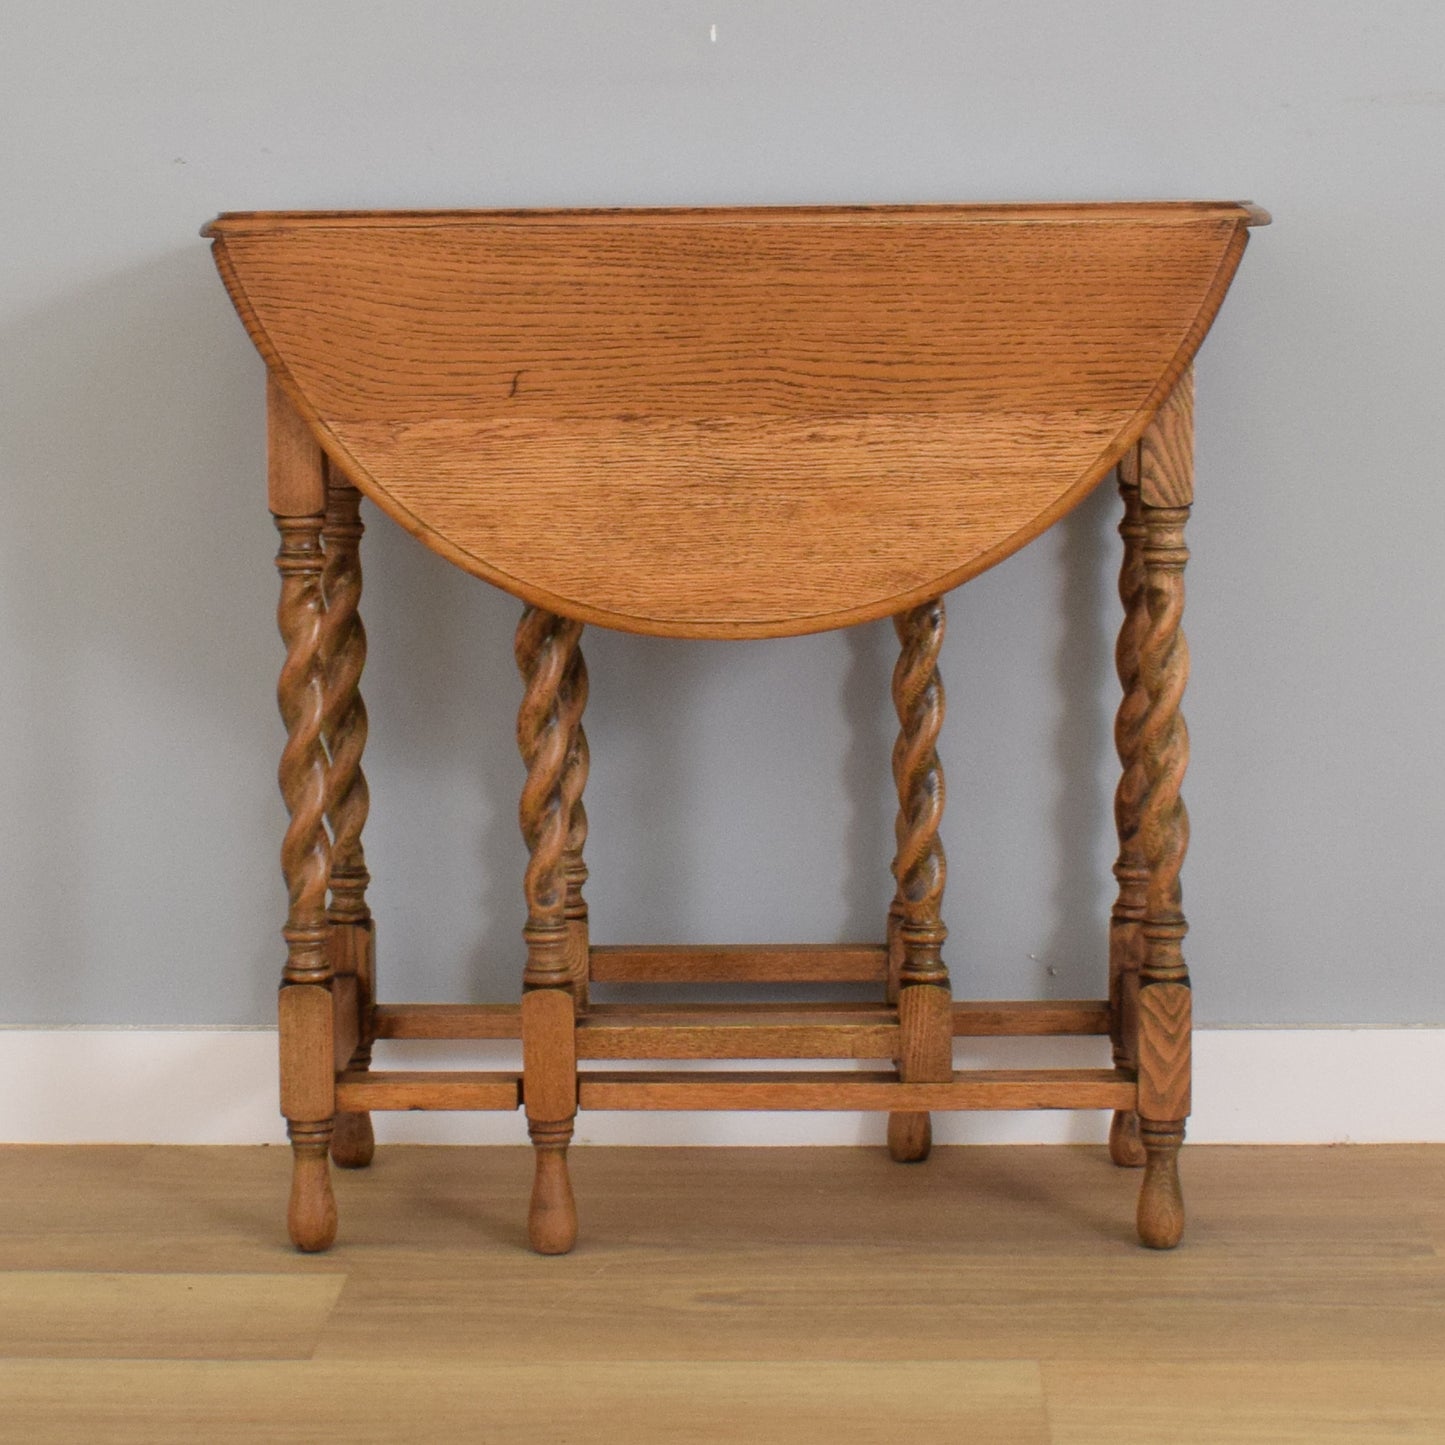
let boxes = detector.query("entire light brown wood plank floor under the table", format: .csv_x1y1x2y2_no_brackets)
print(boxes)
0,1147,1445,1445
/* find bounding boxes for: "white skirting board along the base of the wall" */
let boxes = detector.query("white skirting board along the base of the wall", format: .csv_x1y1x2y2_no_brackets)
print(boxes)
0,1027,1445,1144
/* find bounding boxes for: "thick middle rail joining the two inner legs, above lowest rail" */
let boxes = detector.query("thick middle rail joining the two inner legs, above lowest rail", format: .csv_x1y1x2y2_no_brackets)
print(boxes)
577,1003,899,1059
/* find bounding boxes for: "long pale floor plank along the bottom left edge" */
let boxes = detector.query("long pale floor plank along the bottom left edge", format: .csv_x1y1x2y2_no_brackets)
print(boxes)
0,1361,1049,1445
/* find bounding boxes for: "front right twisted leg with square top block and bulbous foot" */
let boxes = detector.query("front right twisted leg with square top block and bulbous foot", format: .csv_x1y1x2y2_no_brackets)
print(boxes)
1137,373,1194,1248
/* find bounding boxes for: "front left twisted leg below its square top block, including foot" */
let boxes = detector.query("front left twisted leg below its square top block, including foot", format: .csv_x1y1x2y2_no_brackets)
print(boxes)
276,516,337,1250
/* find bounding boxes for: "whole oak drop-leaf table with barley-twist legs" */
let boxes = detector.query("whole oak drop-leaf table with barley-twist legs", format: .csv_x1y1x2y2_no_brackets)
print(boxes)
205,202,1267,1253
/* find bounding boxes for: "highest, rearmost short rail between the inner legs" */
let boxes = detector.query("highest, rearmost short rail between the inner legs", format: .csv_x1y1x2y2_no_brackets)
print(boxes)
591,944,889,984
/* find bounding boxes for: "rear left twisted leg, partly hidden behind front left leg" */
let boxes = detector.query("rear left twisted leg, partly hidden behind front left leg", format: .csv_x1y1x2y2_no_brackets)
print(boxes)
321,467,376,1169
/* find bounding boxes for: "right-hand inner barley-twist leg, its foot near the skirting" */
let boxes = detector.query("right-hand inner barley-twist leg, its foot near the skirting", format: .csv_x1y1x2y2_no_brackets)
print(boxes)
889,598,954,1163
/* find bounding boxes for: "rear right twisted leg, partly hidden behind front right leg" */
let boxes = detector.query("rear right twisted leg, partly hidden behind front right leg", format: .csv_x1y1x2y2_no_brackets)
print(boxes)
1108,448,1149,1169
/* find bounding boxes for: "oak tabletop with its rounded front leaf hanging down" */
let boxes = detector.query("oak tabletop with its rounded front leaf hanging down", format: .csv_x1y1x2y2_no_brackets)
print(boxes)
207,202,1263,637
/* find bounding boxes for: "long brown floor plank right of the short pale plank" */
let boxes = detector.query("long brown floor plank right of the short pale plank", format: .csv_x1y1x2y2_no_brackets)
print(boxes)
316,1247,1445,1361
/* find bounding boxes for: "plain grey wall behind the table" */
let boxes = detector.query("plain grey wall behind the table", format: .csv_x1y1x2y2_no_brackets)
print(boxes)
0,0,1445,1025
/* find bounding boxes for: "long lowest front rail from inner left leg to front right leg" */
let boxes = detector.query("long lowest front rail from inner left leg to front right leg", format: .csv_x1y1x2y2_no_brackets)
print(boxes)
578,1069,1137,1111
